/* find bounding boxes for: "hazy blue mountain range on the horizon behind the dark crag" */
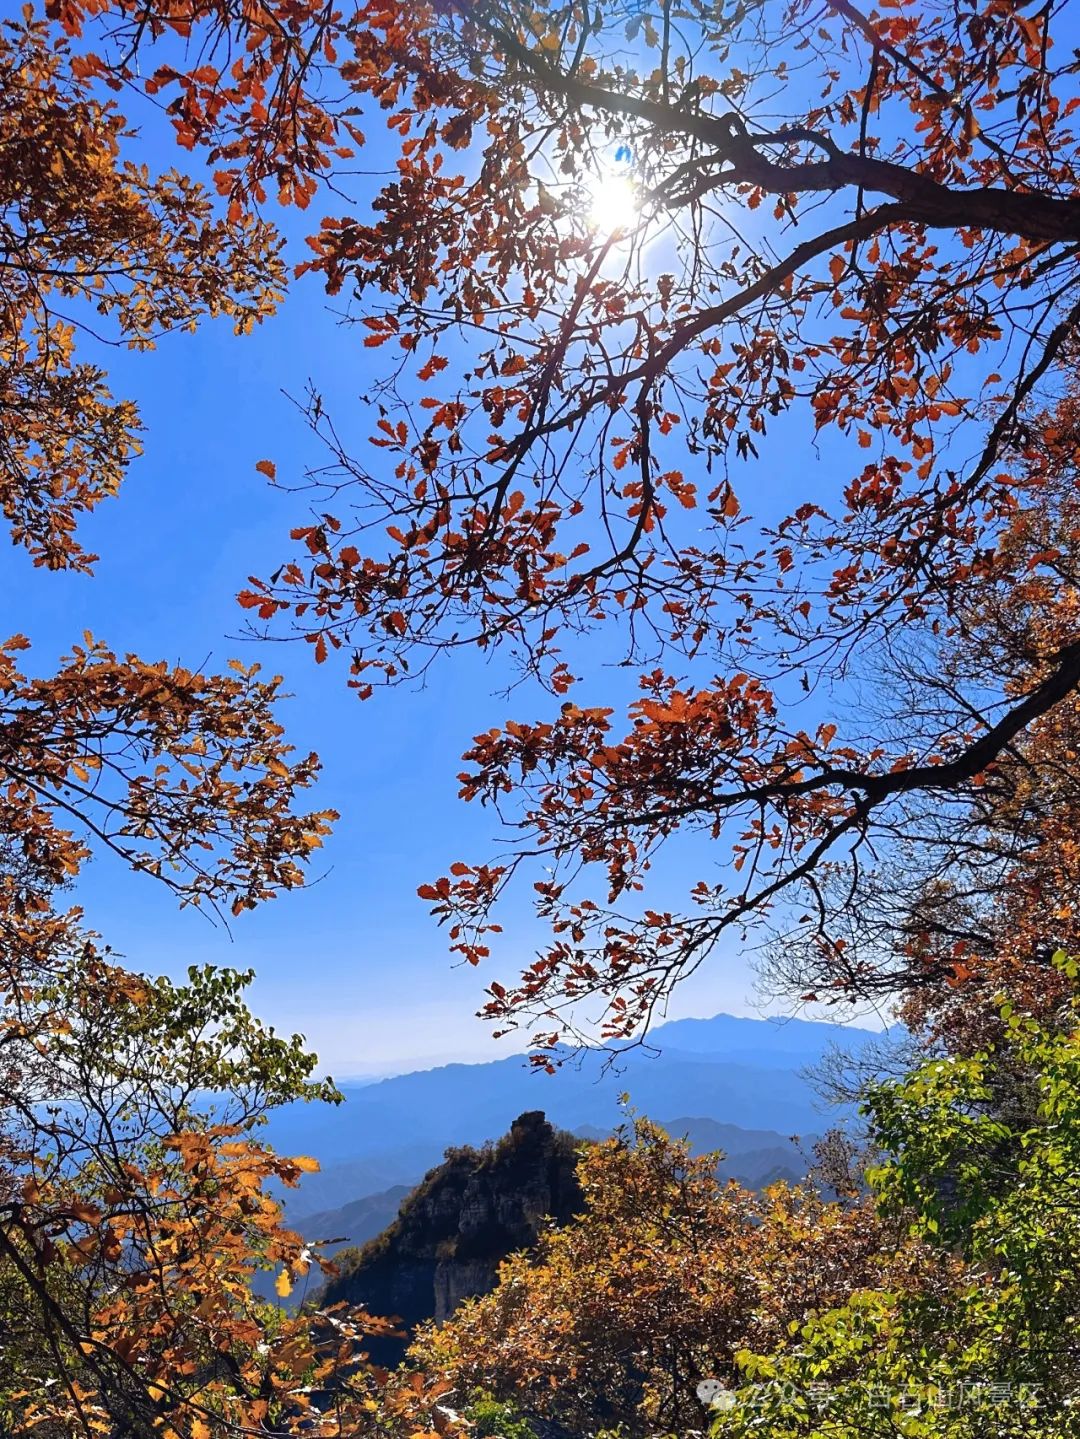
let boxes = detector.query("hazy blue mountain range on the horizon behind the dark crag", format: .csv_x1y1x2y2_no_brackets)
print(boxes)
267,1014,880,1216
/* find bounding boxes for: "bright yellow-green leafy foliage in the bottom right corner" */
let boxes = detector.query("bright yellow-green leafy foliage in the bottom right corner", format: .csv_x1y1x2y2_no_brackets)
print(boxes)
715,954,1080,1439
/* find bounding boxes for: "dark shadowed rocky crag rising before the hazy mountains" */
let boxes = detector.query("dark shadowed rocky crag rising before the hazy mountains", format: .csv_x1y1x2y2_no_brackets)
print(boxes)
322,1111,581,1364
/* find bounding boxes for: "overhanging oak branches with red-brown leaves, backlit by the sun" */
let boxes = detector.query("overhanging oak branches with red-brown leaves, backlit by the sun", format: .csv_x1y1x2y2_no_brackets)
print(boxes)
232,0,1080,1038
